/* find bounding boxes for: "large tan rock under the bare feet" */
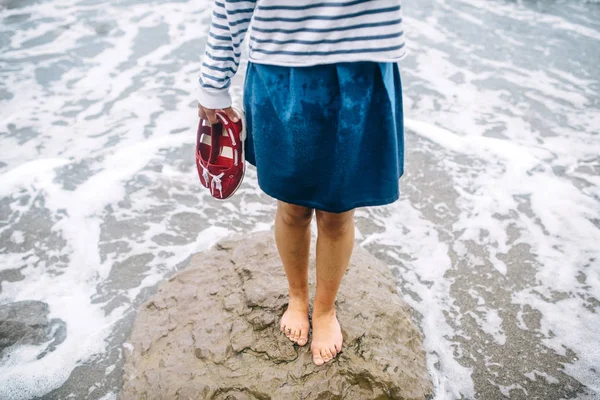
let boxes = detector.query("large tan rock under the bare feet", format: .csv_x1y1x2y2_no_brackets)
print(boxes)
121,232,432,400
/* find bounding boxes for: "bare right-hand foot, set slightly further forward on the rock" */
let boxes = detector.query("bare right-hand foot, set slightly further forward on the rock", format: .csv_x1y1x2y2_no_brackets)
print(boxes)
310,310,343,365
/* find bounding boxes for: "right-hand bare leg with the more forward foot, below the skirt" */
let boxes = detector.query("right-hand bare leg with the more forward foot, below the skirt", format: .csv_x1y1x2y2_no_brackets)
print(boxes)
311,210,354,365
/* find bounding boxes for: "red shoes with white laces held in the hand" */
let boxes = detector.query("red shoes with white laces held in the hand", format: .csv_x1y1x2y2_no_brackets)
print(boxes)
196,110,246,200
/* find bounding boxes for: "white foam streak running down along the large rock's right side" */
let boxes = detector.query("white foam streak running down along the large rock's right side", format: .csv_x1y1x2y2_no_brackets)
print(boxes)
357,201,475,399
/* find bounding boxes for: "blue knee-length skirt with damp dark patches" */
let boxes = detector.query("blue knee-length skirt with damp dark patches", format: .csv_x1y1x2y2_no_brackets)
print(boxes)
244,62,404,213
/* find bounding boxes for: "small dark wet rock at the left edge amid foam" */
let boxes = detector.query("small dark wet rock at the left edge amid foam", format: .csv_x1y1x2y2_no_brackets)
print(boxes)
0,301,67,359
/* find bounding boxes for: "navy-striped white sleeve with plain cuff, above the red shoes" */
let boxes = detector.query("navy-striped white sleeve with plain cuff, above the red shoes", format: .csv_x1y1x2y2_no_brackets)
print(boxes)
198,0,257,109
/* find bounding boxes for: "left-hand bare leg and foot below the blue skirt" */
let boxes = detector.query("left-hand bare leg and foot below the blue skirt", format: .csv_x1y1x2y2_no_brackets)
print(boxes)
275,201,313,346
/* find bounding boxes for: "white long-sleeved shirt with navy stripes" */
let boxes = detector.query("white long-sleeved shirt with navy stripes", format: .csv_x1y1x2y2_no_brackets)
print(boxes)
198,0,404,109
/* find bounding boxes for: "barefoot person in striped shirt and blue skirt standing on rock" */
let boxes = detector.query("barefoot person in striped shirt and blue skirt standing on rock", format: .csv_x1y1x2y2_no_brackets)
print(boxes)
198,0,404,365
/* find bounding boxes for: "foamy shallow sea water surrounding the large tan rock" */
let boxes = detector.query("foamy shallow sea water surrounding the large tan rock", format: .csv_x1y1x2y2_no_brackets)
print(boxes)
0,0,600,400
